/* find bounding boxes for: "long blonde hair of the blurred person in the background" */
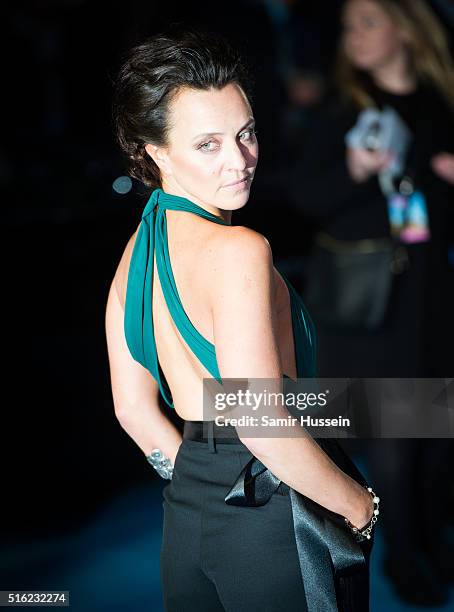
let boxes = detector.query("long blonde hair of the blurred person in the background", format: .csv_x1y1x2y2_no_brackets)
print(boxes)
335,0,454,112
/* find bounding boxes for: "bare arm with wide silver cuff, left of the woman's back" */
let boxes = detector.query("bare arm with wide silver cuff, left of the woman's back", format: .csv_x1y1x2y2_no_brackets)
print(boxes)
105,281,182,464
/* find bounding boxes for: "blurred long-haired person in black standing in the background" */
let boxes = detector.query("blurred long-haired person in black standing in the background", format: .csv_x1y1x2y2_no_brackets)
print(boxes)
286,0,454,605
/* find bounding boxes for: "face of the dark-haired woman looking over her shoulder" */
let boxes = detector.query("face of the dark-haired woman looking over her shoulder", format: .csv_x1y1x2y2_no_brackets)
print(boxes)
153,84,258,210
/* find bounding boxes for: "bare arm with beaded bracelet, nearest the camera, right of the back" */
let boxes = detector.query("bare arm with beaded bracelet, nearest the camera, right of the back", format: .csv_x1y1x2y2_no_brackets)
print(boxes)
210,228,373,527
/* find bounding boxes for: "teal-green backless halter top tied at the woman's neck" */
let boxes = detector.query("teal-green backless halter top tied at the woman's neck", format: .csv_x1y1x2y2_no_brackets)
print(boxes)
124,189,315,408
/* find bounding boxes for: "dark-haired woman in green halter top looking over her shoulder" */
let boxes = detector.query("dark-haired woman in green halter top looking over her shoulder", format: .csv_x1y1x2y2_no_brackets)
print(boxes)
106,33,378,612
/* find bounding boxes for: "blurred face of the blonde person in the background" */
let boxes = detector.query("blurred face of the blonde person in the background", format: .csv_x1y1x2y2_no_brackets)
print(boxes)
342,0,404,72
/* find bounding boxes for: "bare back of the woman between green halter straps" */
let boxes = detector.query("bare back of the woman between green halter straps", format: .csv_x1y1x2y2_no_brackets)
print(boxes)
114,210,296,420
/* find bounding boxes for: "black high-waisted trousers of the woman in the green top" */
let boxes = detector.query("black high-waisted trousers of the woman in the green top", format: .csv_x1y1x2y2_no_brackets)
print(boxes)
160,420,307,612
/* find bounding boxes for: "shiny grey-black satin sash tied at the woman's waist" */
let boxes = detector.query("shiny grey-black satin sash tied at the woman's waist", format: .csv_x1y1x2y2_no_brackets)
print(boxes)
225,439,374,612
